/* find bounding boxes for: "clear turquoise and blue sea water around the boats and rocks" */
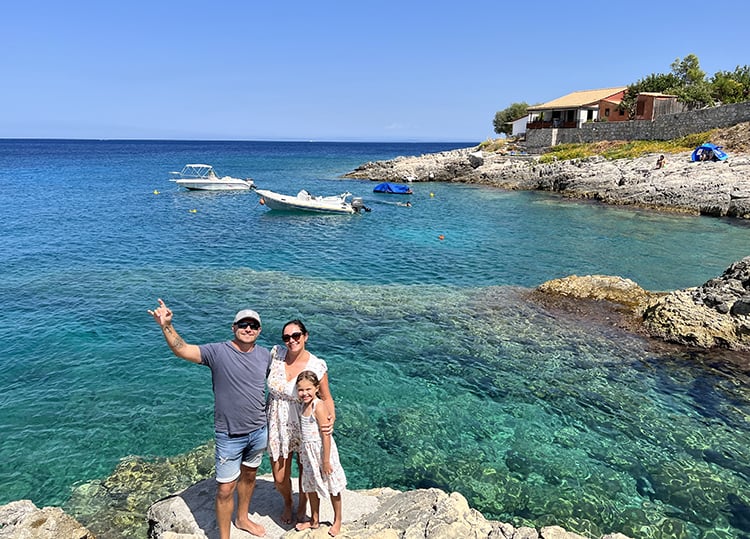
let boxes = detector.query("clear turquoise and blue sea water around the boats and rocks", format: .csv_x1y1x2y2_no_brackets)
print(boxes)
0,140,750,538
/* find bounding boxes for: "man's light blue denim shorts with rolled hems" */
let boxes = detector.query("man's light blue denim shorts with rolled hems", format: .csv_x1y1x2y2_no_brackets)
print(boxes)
216,427,268,483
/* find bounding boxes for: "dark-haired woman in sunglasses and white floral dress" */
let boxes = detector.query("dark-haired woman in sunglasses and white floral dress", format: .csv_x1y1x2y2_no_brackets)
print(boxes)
267,320,336,524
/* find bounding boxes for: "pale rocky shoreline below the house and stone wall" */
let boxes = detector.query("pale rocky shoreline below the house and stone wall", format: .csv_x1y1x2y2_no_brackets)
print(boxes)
344,146,750,219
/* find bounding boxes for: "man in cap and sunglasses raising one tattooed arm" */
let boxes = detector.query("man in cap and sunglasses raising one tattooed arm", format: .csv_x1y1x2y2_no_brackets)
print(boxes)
148,299,271,539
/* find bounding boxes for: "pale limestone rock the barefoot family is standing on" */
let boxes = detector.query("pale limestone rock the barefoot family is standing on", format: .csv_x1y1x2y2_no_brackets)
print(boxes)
148,484,628,539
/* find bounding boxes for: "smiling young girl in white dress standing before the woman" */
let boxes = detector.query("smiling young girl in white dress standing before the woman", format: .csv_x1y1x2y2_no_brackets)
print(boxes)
296,371,346,536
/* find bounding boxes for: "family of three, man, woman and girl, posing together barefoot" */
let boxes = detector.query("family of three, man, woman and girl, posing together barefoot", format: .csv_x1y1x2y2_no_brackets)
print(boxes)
148,299,346,539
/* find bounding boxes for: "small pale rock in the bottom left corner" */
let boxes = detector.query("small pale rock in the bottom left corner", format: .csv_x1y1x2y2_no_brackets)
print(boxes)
0,500,94,539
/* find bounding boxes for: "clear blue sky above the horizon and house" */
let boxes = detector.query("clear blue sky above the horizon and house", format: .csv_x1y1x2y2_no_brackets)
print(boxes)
0,0,750,142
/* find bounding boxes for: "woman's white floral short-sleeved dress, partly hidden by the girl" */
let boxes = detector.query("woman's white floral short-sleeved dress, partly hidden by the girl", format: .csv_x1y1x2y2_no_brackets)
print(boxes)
266,346,328,460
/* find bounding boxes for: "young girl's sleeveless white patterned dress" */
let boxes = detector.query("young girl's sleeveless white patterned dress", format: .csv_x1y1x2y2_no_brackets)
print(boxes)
299,399,346,498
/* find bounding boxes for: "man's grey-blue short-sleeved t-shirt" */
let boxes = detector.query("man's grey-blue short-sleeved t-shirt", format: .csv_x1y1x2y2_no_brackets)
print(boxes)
200,341,271,434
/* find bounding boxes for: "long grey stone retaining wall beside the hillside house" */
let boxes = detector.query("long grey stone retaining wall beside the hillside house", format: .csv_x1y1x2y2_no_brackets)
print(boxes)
526,102,750,152
